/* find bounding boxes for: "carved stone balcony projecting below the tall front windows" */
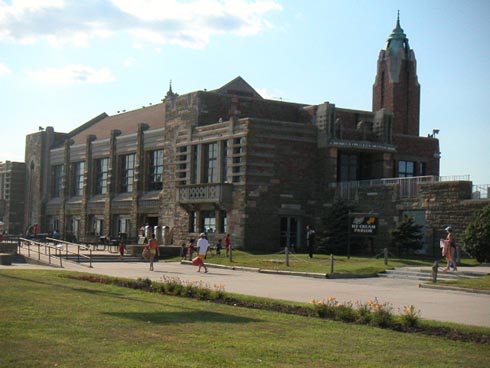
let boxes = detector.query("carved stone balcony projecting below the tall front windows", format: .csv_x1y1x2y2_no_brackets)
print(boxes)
176,183,233,209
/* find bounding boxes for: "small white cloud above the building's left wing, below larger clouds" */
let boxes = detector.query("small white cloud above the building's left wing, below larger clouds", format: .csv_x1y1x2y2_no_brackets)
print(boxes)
28,65,116,85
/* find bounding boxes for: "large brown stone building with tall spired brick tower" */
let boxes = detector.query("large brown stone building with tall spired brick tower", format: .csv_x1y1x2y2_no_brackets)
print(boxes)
25,20,454,251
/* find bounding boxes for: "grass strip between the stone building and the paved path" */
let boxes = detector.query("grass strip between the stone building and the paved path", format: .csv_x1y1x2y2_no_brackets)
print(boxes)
172,250,477,275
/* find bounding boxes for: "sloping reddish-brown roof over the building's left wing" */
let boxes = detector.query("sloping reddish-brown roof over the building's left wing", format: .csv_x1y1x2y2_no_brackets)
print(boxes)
68,103,165,144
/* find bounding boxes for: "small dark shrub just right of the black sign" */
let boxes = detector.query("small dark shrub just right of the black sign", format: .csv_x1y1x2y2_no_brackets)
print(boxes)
390,215,423,254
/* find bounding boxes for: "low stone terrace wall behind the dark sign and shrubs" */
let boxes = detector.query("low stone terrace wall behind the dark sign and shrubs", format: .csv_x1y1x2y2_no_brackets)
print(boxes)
325,181,490,255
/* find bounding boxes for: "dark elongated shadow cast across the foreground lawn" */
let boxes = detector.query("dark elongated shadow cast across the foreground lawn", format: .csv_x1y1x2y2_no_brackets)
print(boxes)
104,311,262,324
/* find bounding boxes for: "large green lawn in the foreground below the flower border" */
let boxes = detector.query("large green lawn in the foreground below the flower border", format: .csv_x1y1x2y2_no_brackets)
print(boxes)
0,270,490,368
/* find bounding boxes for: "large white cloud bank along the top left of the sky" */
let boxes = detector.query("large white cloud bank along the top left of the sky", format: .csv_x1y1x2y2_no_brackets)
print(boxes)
0,0,282,48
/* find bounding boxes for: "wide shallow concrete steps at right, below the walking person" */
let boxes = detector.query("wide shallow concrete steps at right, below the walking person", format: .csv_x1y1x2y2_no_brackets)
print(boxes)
378,267,486,281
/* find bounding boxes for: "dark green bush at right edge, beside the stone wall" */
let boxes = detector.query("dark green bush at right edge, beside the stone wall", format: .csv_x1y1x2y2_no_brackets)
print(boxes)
461,205,490,262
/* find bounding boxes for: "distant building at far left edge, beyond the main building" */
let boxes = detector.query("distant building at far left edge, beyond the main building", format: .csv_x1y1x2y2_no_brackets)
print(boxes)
0,161,26,234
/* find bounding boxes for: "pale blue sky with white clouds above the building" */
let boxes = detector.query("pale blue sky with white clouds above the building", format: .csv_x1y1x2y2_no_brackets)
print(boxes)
0,0,490,184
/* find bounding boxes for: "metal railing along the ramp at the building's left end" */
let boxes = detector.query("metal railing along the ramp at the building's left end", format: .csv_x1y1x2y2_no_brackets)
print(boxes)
17,238,92,268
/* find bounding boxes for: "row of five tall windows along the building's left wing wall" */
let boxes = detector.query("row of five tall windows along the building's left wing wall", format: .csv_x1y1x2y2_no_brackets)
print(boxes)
51,150,163,198
